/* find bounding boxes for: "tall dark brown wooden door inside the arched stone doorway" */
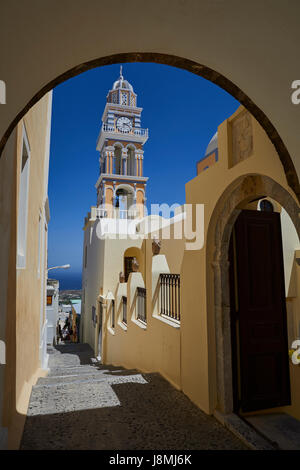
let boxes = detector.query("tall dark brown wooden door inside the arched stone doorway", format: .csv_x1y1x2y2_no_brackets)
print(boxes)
229,210,290,411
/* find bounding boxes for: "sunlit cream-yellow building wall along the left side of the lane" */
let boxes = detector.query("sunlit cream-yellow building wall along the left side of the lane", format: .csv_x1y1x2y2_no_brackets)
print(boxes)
0,92,52,448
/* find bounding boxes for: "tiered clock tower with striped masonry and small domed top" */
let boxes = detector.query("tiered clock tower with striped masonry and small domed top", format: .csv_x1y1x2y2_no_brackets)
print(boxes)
96,66,148,219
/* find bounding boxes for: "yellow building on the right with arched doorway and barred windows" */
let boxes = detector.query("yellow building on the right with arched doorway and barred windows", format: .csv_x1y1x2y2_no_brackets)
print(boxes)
85,106,300,434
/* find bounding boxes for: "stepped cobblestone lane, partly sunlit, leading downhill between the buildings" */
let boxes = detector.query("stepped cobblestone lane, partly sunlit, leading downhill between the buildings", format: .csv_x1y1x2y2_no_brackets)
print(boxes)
21,344,246,450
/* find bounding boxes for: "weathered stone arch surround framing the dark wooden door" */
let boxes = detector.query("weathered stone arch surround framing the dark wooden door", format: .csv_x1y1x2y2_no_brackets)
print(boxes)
207,174,300,414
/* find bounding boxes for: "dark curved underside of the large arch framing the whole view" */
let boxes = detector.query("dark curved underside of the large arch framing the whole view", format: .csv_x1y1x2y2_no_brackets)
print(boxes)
0,52,300,200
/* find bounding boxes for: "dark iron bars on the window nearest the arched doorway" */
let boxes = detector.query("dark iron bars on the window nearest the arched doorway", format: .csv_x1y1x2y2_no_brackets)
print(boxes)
160,274,180,321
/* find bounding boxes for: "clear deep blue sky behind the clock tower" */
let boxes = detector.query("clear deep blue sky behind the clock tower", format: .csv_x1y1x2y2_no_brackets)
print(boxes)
48,63,239,288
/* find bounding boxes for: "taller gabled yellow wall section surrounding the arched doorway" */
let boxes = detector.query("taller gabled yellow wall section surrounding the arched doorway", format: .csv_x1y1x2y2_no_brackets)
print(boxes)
181,107,299,418
